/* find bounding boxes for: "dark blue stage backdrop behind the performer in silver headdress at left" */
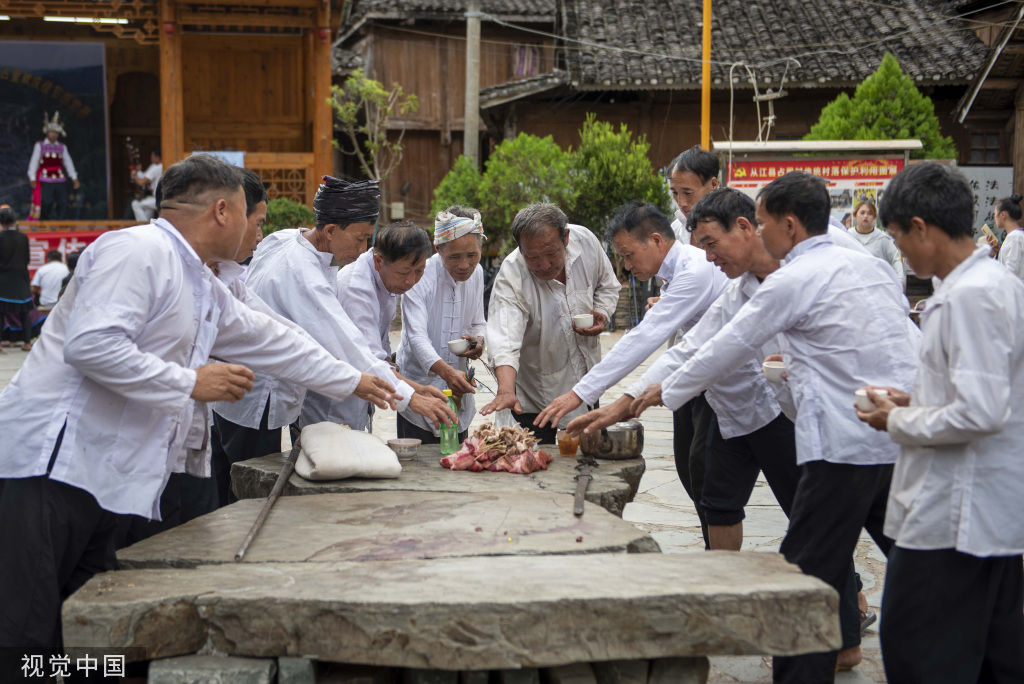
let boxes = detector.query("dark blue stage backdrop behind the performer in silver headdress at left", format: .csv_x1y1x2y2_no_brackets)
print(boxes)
0,40,109,220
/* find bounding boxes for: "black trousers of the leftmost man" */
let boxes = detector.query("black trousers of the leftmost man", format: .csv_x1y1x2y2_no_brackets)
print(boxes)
0,475,117,647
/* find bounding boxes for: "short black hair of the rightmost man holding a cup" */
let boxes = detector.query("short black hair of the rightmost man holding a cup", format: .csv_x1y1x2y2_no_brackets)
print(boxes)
879,162,974,239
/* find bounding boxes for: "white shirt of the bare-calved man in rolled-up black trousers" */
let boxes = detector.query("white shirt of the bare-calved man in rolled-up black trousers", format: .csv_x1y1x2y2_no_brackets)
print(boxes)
627,273,782,439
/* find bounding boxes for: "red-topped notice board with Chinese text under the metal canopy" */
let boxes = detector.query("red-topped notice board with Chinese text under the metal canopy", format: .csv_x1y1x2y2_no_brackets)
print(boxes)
728,157,903,220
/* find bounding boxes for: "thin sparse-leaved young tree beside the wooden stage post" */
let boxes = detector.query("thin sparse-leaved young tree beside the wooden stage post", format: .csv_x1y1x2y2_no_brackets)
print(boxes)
328,69,420,181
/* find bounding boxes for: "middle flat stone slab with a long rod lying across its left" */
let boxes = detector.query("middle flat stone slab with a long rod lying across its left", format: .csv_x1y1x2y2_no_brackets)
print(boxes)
118,491,660,569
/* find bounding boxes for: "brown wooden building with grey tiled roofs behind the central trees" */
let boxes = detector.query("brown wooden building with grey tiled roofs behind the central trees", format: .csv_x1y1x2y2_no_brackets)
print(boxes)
335,0,988,216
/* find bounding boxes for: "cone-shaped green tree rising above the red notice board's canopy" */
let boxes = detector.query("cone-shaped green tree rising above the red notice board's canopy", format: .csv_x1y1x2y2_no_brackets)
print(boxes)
804,52,956,159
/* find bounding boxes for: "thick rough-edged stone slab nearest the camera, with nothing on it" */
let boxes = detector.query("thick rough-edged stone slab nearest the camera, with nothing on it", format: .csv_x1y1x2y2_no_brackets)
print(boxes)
63,552,841,670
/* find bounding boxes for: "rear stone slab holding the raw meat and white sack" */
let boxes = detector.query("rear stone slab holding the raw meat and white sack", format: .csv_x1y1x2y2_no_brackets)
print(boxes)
231,444,644,516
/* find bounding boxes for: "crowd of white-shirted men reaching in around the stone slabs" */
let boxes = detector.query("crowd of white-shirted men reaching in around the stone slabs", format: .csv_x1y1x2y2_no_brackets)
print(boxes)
0,148,1024,683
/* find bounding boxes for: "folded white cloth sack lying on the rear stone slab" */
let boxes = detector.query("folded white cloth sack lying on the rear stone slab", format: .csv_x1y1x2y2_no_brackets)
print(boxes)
295,423,401,480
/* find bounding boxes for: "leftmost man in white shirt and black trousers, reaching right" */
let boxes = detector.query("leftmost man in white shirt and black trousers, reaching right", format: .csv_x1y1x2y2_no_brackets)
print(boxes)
0,156,393,648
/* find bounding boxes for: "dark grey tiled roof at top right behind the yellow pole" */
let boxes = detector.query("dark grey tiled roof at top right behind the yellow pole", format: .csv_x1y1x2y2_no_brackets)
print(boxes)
560,0,988,89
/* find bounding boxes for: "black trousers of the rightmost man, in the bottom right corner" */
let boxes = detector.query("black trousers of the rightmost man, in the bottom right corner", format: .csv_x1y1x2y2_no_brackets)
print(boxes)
881,546,1024,684
